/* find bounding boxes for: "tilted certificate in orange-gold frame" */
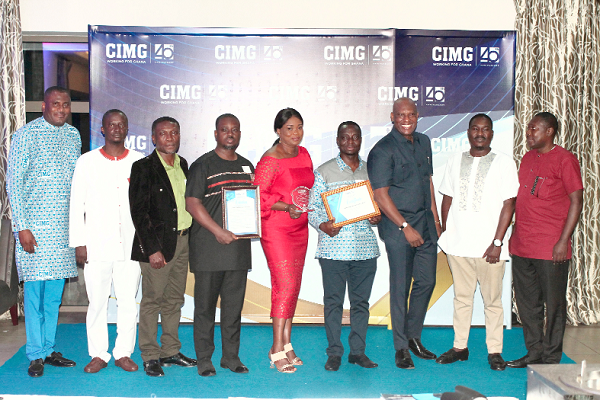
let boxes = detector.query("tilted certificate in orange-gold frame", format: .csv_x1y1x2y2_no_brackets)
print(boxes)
321,181,381,228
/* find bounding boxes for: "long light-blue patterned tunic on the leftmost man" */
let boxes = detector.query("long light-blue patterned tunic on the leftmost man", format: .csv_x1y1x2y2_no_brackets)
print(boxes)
6,117,81,281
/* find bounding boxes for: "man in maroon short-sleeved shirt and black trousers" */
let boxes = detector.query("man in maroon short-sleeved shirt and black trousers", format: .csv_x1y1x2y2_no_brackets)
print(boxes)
506,112,583,368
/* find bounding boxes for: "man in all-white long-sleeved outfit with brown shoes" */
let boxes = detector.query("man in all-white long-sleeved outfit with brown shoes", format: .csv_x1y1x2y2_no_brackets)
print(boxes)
69,109,144,373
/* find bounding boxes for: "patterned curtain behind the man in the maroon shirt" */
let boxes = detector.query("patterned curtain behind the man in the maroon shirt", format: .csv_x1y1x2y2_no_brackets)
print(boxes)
515,0,600,325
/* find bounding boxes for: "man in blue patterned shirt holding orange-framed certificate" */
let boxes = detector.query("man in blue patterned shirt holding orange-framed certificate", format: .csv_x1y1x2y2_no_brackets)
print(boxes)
308,121,381,371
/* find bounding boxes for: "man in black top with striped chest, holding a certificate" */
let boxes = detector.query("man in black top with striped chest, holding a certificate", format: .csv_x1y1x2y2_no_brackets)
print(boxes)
185,114,254,376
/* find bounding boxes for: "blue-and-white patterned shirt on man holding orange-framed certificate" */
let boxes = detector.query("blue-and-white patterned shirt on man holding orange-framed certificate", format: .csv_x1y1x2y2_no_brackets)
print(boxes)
308,155,379,260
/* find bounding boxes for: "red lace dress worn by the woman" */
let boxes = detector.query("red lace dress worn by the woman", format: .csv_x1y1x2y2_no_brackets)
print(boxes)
254,147,315,319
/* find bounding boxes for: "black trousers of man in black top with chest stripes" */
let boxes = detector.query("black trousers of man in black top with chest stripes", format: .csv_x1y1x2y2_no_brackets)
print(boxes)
194,270,248,365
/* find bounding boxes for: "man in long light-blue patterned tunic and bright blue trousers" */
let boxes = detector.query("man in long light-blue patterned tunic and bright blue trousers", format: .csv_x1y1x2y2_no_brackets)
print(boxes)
6,86,81,377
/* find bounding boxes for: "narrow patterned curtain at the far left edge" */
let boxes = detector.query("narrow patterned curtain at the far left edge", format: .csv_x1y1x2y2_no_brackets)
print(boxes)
0,0,25,218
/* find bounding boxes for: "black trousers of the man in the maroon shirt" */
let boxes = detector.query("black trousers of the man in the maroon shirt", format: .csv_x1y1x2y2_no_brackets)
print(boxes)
512,256,569,364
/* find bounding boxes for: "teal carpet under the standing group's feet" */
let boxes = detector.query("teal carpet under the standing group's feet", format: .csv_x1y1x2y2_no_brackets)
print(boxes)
0,324,573,399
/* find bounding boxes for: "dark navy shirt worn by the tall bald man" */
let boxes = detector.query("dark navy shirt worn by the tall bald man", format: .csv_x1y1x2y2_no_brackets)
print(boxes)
367,128,437,242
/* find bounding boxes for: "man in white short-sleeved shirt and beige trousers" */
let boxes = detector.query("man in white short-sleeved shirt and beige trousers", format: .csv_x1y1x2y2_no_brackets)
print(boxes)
436,114,519,371
